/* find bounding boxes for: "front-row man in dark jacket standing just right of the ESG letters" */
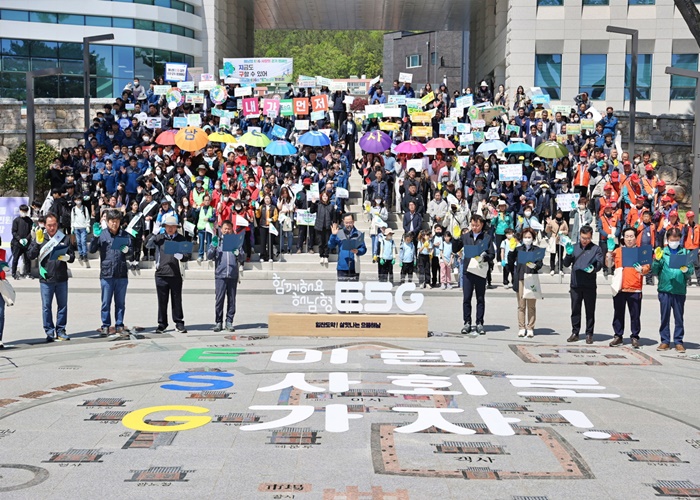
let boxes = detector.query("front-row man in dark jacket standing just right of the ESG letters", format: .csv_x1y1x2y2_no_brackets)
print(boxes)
452,214,495,335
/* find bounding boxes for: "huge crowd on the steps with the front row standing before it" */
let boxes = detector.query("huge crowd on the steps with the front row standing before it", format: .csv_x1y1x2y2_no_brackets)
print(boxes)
0,76,700,350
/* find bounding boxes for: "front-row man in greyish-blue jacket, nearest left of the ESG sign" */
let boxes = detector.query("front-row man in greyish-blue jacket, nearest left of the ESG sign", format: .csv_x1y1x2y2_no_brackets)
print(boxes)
207,220,245,332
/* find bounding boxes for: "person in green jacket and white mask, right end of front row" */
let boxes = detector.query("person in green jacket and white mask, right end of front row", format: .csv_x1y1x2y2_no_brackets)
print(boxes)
651,227,694,352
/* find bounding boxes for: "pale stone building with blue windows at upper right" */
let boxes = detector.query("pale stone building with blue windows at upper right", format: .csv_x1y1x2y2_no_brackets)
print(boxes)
470,0,700,115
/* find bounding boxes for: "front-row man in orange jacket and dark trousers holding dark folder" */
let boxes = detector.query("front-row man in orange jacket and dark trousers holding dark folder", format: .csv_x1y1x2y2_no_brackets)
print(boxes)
606,227,651,349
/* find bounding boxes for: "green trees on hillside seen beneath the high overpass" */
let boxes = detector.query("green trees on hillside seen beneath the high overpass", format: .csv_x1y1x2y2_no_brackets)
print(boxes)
255,30,384,80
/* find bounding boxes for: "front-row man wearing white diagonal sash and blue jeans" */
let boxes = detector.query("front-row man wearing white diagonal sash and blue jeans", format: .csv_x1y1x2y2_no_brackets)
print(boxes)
27,213,75,342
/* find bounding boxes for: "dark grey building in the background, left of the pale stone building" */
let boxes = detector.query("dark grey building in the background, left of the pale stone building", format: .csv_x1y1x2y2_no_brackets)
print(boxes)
384,31,469,91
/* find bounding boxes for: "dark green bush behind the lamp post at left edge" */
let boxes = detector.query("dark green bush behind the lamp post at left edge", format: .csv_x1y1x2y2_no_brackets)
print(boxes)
0,141,58,199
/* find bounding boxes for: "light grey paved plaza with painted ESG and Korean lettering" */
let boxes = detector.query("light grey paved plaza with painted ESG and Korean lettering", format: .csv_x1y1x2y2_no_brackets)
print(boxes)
0,279,700,500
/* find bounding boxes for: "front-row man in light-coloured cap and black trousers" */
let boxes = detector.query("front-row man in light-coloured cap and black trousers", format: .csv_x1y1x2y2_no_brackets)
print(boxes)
146,215,192,333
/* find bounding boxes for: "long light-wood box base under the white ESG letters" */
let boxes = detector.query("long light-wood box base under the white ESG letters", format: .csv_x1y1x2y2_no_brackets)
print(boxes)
268,313,428,338
